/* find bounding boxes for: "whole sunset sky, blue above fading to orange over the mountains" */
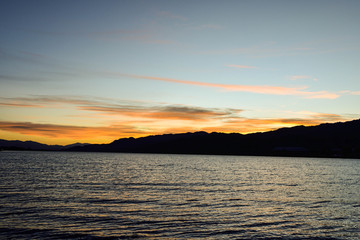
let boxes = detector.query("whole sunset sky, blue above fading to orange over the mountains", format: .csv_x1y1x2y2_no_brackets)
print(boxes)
0,0,360,145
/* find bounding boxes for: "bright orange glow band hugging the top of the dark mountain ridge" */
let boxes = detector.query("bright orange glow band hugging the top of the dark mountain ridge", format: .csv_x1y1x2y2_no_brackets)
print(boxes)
0,114,345,145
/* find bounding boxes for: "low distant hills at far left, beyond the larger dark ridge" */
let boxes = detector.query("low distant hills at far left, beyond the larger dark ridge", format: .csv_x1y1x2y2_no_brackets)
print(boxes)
0,139,88,151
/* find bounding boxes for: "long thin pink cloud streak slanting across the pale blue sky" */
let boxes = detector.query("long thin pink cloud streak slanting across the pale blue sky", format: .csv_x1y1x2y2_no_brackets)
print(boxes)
115,73,340,99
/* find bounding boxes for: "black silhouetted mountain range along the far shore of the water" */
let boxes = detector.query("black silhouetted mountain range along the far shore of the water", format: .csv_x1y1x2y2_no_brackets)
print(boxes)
0,119,360,158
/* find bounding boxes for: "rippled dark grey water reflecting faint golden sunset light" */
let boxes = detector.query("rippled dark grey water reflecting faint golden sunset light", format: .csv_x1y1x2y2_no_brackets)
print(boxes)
0,152,360,239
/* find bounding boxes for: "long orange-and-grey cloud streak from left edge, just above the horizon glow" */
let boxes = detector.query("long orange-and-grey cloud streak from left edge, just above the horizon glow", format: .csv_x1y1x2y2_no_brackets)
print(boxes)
0,96,242,121
